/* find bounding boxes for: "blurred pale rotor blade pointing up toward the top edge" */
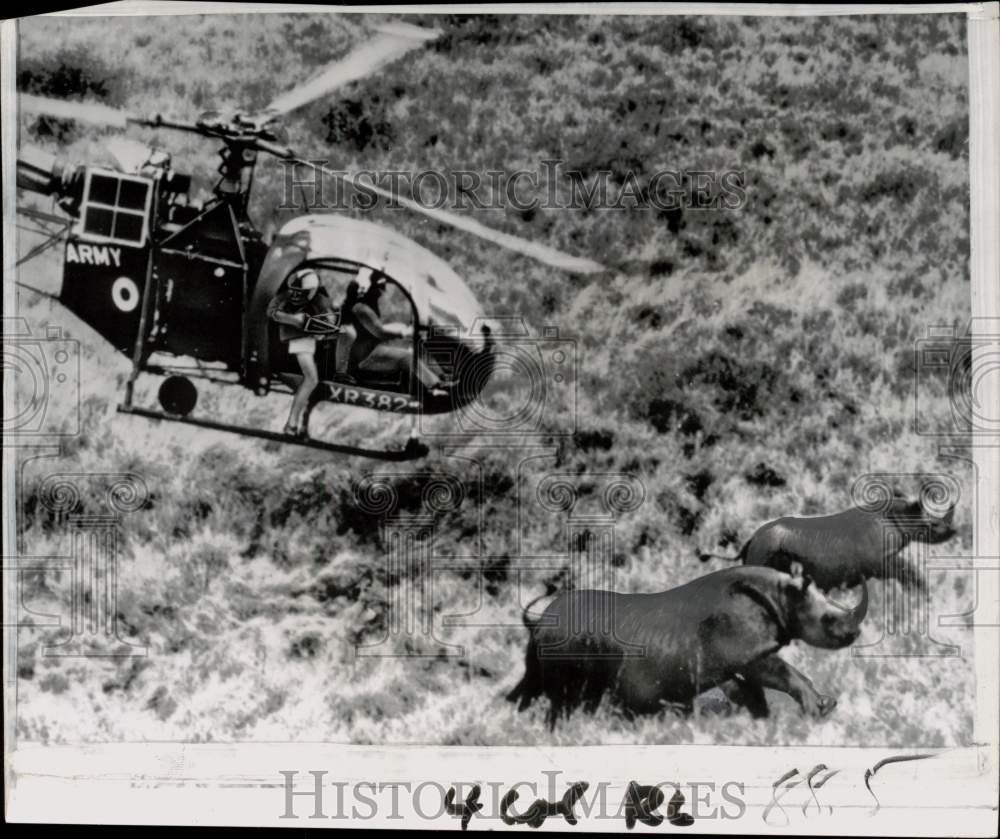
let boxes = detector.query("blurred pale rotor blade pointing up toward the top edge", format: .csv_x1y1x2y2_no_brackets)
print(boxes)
264,23,440,114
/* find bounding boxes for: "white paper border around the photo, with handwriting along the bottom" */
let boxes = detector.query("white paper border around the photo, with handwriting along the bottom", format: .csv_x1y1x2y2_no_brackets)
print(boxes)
2,2,1000,836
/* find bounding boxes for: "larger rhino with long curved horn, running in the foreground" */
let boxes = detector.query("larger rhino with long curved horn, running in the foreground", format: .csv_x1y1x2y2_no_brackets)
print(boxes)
507,566,868,728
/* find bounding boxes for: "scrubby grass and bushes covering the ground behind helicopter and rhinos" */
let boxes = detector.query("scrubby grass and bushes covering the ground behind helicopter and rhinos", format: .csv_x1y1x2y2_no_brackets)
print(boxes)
11,14,975,746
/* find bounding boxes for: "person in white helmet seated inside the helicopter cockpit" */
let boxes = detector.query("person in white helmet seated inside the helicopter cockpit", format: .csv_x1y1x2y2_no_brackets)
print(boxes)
344,269,451,396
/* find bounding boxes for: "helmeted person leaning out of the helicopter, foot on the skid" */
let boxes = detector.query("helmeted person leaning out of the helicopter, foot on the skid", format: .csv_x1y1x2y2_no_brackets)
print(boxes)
267,268,336,437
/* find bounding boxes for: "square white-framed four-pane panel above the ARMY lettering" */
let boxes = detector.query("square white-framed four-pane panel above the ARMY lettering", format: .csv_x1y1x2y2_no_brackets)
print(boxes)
77,169,153,248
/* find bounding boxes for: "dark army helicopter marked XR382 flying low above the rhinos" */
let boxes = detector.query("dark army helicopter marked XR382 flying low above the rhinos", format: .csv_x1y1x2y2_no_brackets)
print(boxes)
17,23,604,460
